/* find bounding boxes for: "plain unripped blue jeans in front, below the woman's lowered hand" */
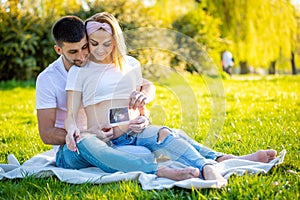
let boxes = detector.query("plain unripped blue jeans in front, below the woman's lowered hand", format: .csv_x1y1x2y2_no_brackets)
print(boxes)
56,136,158,174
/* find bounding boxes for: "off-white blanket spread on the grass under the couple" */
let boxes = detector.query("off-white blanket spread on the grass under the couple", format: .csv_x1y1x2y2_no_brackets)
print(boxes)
0,150,286,190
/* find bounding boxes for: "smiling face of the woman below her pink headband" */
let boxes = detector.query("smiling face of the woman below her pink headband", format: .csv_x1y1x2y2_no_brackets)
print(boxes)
89,29,114,64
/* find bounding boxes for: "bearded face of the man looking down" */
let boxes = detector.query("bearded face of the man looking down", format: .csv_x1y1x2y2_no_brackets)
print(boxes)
55,37,89,70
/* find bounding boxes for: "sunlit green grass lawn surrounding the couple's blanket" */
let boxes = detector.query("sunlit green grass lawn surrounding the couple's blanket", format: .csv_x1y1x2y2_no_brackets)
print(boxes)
0,74,300,199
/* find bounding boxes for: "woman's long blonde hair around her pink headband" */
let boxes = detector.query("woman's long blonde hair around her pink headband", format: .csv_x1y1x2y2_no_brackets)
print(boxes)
85,12,127,71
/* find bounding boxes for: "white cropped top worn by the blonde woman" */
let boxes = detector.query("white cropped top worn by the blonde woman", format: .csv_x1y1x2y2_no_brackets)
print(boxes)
66,56,142,107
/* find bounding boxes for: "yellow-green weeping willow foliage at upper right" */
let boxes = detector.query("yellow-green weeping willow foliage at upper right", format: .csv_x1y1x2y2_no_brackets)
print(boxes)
206,0,296,73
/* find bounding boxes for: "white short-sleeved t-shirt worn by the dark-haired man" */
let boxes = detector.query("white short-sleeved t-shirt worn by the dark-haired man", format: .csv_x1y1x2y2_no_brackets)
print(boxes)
36,56,86,151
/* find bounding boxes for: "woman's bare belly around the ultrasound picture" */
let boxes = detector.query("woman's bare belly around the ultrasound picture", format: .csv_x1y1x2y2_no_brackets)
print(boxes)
85,99,139,139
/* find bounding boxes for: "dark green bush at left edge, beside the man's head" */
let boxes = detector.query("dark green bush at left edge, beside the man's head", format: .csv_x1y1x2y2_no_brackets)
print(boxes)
0,9,56,80
